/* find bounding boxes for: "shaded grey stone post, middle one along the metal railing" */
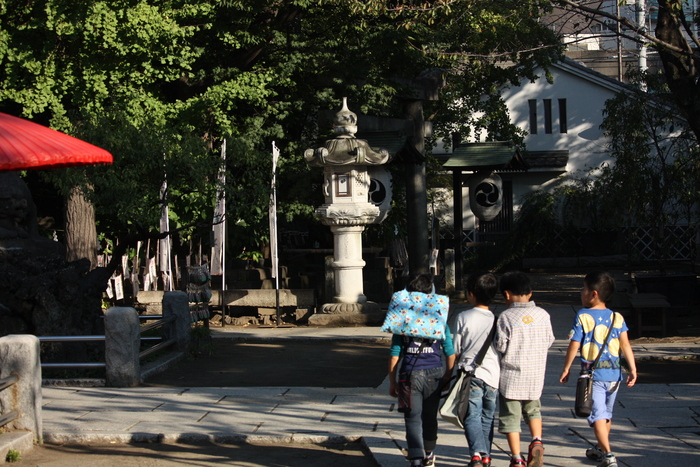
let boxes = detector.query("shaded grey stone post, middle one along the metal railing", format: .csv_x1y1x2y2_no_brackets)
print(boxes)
105,307,141,387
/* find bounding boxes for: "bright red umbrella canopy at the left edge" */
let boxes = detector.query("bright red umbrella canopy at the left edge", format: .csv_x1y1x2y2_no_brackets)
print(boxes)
0,113,113,172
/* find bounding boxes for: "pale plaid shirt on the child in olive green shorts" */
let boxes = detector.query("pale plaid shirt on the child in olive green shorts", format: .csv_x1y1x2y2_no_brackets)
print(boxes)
495,302,554,400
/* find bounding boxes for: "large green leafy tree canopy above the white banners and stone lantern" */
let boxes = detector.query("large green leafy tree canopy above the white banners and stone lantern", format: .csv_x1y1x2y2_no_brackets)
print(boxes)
0,0,561,278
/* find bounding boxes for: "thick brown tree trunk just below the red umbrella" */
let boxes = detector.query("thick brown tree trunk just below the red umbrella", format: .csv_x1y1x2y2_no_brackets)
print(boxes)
66,187,97,269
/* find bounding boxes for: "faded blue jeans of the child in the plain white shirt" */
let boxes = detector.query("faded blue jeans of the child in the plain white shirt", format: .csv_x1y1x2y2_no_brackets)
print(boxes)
464,377,498,457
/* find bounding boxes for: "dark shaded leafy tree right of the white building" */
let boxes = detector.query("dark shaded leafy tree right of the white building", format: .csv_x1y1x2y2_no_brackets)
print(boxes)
562,72,700,271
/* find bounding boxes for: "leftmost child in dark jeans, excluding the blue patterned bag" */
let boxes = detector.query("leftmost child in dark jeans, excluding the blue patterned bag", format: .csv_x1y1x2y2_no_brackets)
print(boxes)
389,274,455,467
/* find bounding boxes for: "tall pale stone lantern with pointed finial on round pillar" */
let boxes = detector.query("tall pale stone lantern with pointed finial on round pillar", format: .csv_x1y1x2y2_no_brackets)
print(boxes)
304,98,391,324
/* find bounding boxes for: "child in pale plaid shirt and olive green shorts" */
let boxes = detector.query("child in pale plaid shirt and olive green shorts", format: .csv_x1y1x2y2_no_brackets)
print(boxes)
496,271,554,467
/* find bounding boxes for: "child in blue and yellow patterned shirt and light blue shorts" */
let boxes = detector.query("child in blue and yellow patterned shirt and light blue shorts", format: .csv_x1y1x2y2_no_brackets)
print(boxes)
559,272,637,467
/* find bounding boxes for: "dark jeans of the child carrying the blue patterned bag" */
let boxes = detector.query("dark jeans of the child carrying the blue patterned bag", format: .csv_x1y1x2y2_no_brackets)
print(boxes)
404,367,444,459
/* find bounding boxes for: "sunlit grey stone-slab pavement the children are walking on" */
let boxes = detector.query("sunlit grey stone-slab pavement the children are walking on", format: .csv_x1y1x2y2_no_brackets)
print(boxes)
37,305,700,467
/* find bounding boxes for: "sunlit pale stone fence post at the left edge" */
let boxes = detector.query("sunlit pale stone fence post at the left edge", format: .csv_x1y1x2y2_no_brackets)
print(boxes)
0,334,43,442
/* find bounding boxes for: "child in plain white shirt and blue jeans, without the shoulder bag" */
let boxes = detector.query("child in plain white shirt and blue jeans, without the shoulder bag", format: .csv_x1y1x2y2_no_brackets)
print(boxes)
454,272,500,467
